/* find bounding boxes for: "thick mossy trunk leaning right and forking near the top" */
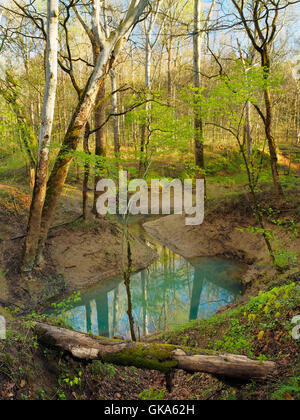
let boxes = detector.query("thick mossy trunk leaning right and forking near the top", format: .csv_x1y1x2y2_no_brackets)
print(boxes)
37,0,148,261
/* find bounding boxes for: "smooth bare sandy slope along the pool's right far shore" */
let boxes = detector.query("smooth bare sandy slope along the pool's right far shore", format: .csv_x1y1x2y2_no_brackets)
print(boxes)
144,215,268,264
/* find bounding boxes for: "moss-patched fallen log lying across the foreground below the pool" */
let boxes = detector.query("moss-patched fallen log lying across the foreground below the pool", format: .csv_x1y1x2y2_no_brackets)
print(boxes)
36,323,276,380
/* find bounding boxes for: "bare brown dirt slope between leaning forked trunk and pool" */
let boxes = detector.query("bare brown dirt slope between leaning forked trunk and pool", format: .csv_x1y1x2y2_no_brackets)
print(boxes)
47,220,158,290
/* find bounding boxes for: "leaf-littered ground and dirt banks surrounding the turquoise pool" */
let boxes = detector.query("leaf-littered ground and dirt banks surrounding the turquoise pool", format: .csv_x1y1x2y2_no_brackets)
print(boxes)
0,154,300,400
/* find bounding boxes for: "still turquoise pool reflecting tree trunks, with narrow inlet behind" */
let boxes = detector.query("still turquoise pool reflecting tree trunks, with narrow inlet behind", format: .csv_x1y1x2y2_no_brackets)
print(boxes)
48,218,244,338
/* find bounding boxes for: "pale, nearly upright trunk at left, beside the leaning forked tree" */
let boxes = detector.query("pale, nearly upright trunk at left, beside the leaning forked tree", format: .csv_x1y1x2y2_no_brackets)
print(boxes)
21,0,58,274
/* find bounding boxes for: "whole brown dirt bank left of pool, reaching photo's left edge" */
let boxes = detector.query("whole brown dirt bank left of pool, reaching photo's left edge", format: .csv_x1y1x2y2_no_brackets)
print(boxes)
0,185,158,307
